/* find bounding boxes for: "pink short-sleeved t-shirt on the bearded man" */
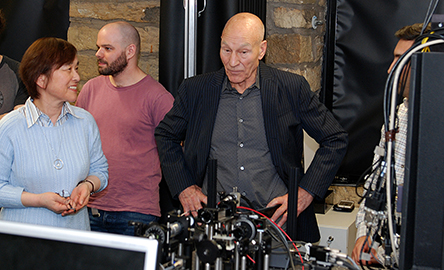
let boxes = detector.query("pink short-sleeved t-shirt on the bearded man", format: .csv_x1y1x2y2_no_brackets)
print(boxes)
76,75,174,216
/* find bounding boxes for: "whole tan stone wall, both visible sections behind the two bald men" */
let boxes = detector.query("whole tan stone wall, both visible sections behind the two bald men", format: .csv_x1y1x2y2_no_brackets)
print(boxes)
68,0,326,91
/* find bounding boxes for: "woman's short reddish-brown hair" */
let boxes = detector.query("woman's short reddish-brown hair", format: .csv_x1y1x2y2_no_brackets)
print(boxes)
20,37,77,99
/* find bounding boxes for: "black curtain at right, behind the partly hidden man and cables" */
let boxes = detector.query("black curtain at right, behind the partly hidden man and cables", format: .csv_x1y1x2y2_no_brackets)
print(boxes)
321,0,443,184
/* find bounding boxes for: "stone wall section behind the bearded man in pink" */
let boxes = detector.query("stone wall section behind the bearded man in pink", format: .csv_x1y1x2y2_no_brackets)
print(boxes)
68,0,160,88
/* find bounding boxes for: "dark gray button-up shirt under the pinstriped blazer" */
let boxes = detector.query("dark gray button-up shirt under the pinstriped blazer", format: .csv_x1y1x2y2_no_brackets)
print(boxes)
203,73,287,209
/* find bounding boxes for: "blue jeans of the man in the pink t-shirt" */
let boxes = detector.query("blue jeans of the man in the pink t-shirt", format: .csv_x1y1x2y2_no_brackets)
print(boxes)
88,207,159,235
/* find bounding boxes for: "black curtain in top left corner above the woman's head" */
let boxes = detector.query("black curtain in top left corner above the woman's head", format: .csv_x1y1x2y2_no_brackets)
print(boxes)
0,0,69,61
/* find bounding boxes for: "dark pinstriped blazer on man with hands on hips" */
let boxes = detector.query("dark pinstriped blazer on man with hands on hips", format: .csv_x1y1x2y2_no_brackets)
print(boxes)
155,62,348,242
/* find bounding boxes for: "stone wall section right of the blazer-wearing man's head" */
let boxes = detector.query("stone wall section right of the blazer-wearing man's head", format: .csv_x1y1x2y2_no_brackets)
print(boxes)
265,0,327,92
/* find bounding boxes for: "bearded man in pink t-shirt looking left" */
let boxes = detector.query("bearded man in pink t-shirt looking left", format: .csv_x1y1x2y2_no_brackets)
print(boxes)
76,22,174,235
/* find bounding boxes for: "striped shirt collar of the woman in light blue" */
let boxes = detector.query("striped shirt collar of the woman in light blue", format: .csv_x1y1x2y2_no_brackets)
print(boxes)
23,98,80,128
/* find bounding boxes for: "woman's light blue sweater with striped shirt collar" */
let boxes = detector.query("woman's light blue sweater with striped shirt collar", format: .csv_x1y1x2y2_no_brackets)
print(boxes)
0,99,108,230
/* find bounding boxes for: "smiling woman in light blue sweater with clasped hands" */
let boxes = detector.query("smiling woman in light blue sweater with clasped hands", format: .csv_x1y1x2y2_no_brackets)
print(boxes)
0,38,108,230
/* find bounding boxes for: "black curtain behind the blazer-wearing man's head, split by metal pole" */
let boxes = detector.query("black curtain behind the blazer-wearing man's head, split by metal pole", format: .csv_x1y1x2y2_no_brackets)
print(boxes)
159,0,266,96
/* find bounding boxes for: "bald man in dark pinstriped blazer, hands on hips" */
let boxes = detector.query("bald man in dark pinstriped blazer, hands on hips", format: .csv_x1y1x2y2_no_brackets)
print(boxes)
155,13,347,242
